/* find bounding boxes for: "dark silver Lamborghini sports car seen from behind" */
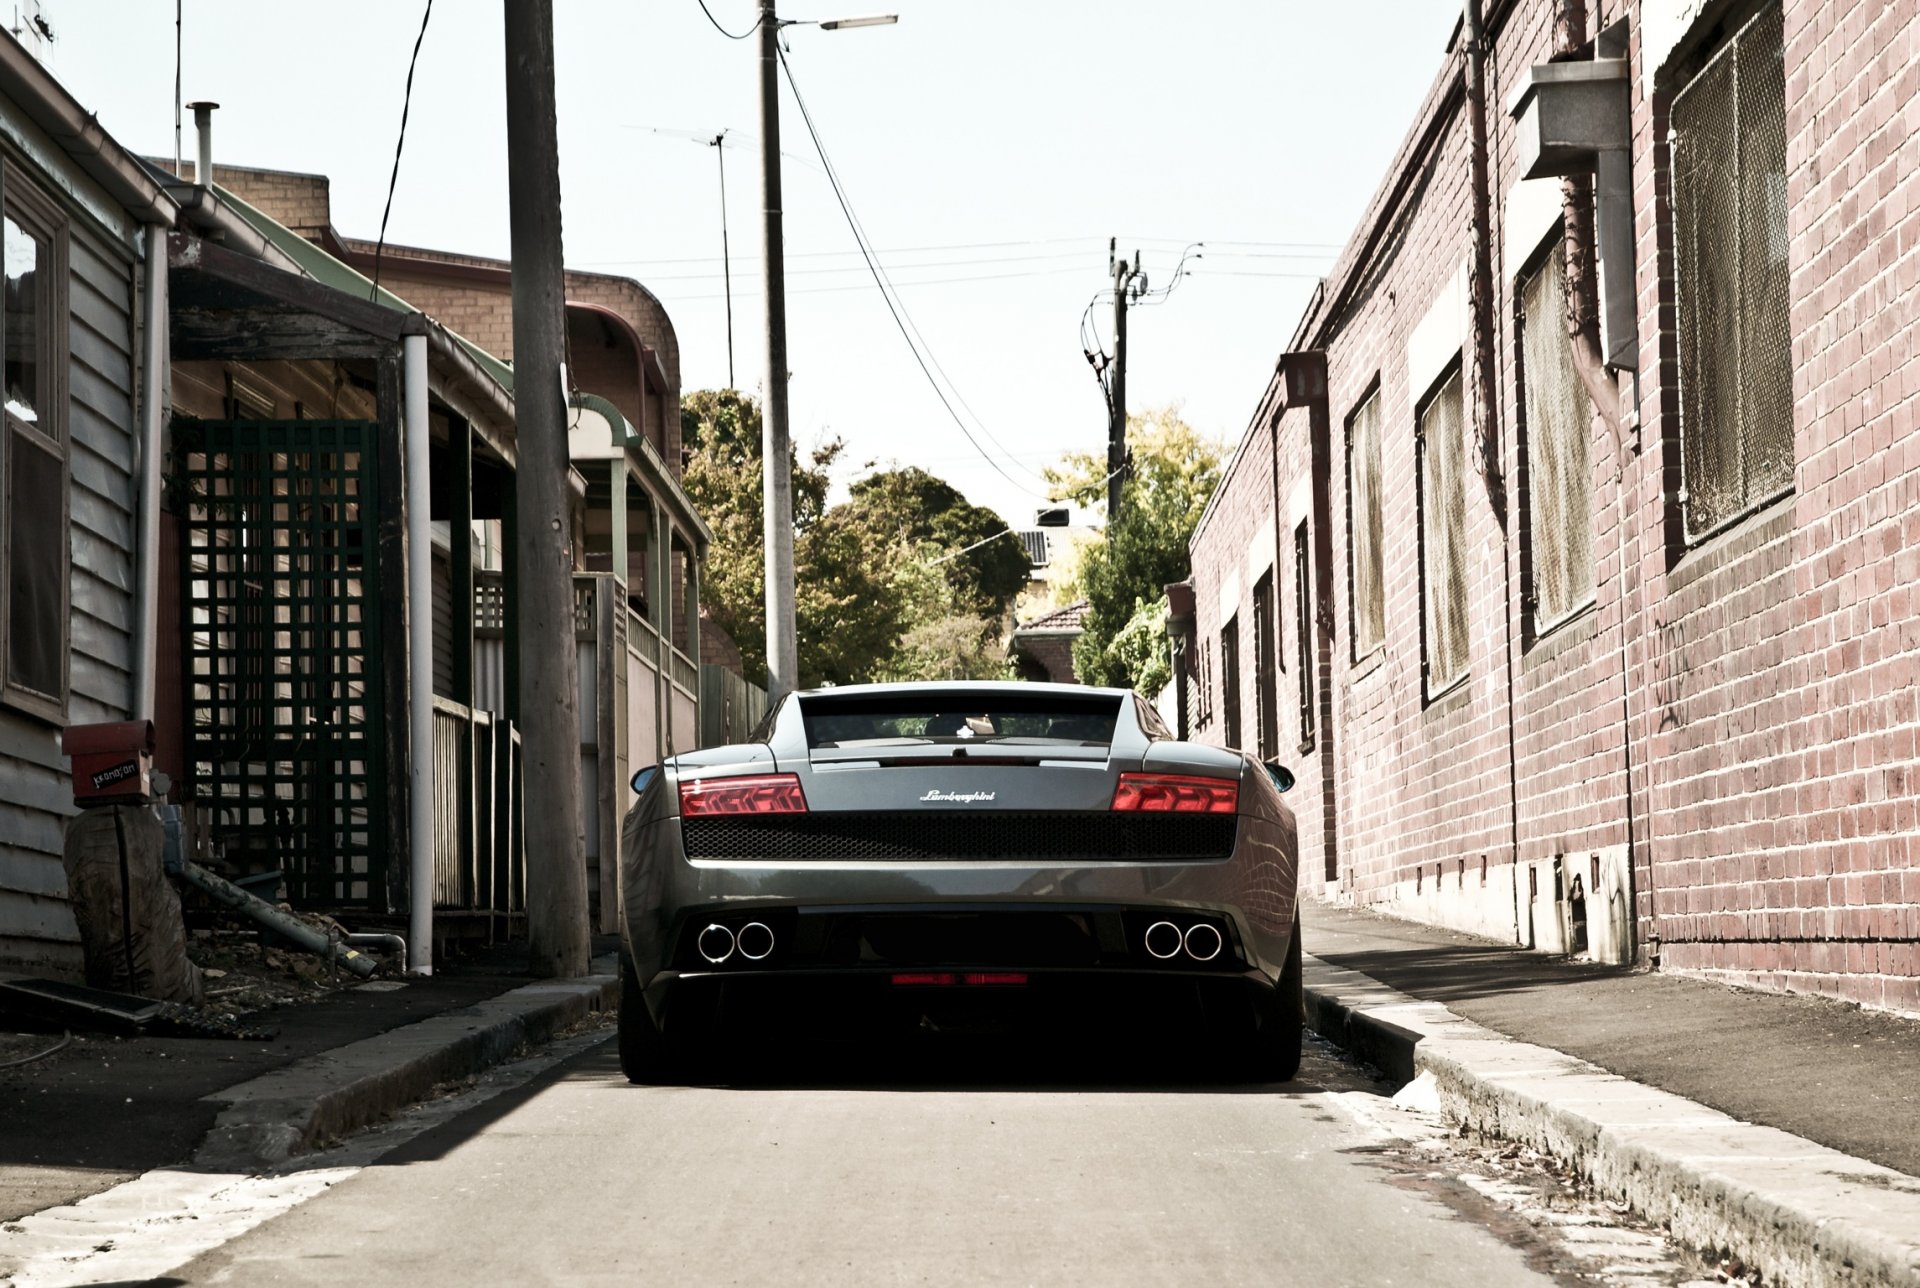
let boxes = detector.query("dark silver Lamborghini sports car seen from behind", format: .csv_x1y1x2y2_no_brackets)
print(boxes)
620,681,1302,1083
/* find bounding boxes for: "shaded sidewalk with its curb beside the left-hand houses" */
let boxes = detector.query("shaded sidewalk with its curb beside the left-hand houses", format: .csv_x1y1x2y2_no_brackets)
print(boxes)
0,946,620,1221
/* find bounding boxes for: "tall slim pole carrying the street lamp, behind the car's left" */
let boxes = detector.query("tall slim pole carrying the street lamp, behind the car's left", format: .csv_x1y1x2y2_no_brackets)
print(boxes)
760,0,801,703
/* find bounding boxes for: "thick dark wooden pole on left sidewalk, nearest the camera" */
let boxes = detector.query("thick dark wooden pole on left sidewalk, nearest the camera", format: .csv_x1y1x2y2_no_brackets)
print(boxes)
503,0,589,977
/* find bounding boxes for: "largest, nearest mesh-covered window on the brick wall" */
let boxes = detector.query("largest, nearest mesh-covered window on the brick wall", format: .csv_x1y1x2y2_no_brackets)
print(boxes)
1672,6,1793,539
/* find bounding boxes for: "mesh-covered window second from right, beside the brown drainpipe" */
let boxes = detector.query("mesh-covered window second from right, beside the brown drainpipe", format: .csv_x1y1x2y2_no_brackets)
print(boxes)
1521,255,1594,630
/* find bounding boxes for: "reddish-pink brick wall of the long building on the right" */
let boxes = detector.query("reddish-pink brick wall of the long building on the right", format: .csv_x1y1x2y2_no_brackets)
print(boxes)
1192,0,1920,1014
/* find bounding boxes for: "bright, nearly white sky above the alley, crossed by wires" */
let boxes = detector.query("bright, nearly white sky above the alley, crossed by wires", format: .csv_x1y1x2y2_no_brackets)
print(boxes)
42,0,1459,526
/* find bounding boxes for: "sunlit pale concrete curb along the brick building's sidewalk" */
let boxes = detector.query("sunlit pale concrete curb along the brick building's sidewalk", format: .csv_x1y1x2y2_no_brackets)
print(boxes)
1306,956,1920,1286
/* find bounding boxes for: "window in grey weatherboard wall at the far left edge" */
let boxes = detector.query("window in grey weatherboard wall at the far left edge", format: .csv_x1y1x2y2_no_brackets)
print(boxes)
0,161,69,720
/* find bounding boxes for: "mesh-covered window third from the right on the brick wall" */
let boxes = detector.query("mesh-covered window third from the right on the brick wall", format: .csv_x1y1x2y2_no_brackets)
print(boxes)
1419,370,1467,693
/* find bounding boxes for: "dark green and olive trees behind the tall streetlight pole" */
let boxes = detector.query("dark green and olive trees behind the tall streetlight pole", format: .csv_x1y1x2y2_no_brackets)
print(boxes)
680,390,1029,687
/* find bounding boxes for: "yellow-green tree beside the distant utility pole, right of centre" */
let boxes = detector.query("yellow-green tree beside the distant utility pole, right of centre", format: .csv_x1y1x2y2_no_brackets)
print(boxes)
1046,407,1225,689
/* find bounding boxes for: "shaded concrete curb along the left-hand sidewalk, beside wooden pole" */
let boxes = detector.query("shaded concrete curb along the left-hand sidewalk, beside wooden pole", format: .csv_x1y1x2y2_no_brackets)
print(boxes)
194,956,620,1171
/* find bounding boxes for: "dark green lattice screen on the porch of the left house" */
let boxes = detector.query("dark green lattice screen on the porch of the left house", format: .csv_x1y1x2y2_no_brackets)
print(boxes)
173,420,388,910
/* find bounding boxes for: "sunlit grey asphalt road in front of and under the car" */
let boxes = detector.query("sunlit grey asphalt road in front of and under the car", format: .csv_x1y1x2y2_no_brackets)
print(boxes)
0,1033,1693,1288
